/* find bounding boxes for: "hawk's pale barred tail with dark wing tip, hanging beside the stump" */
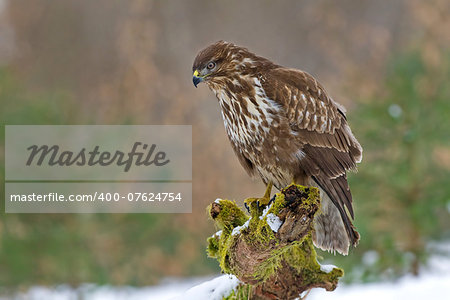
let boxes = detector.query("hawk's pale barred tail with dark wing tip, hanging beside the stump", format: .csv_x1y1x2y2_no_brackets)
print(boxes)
312,177,360,255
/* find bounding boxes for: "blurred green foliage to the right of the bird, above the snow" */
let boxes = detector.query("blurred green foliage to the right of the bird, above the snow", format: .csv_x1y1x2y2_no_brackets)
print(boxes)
320,51,450,280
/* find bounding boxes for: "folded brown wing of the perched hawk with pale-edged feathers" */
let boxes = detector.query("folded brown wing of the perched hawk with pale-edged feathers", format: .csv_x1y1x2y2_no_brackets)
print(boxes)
265,68,362,251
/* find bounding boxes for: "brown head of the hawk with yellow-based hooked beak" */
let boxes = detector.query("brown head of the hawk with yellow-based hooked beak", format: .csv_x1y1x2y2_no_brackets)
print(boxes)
192,41,270,87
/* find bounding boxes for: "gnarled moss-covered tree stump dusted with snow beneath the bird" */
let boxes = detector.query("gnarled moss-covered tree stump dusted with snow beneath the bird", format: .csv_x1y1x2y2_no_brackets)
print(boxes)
207,184,344,299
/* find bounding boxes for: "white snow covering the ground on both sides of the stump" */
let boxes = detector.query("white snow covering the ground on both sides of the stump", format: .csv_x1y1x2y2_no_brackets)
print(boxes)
4,252,450,300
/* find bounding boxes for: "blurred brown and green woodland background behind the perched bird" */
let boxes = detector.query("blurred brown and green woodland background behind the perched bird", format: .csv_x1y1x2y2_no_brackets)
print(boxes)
0,0,450,292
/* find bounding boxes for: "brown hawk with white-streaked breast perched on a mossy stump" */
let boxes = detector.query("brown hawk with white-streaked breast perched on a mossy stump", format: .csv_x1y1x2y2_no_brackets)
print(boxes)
192,41,362,255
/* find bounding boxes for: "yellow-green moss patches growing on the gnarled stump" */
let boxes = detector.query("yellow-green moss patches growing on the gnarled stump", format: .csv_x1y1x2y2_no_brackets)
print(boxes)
207,185,343,299
